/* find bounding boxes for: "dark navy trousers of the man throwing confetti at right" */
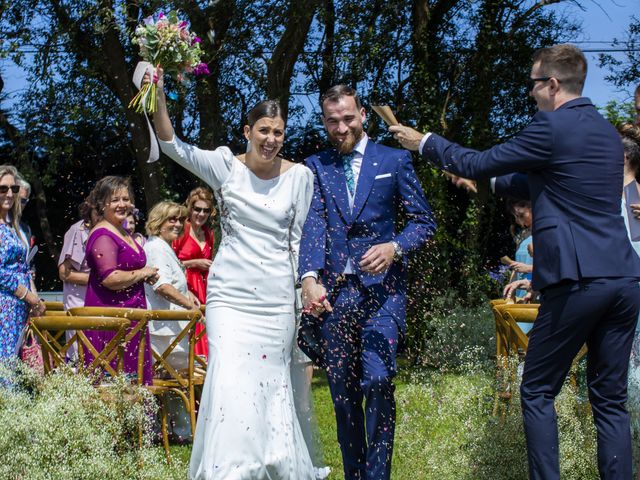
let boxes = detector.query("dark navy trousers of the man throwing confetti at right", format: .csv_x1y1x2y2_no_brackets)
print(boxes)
520,278,640,480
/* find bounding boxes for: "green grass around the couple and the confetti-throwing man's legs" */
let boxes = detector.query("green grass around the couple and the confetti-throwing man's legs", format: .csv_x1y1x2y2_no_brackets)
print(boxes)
158,369,598,480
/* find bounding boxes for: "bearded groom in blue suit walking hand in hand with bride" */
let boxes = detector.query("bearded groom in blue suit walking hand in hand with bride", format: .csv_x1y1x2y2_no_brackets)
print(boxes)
299,85,435,480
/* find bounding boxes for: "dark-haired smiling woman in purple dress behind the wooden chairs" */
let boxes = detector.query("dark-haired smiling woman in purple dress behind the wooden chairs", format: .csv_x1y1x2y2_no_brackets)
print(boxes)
84,176,158,385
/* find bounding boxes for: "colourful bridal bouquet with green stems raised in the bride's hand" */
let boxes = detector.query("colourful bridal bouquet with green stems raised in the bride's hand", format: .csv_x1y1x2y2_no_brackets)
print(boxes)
129,11,209,113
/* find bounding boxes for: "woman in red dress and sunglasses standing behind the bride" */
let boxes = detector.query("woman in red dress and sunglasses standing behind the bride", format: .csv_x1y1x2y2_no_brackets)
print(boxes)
172,187,215,358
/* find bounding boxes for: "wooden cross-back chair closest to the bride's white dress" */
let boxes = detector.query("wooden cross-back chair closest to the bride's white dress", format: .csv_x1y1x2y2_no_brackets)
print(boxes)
147,310,206,462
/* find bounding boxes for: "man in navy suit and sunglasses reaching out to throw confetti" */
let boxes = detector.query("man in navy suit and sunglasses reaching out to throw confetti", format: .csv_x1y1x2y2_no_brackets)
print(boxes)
390,45,640,479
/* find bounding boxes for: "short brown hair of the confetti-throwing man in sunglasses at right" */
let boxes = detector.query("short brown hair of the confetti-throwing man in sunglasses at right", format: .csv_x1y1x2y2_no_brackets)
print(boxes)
533,43,587,95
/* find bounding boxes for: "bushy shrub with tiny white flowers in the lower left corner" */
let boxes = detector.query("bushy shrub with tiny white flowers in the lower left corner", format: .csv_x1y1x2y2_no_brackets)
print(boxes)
0,366,186,480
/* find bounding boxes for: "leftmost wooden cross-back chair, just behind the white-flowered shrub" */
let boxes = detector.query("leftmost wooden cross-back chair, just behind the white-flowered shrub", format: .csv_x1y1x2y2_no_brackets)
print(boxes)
29,315,131,376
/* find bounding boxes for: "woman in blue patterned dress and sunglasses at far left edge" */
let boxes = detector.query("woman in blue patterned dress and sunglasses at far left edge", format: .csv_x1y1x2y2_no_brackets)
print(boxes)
0,165,45,364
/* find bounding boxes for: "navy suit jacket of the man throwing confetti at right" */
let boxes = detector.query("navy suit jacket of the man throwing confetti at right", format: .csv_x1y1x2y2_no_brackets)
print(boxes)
422,97,640,290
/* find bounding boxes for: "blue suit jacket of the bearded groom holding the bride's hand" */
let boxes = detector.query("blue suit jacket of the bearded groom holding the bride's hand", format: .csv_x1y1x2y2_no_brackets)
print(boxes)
299,139,436,331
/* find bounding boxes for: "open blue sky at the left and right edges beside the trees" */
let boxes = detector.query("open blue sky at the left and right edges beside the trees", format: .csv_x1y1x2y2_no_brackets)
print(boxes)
0,0,640,108
